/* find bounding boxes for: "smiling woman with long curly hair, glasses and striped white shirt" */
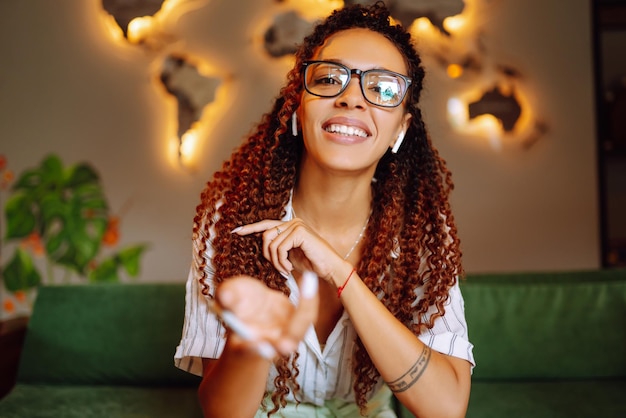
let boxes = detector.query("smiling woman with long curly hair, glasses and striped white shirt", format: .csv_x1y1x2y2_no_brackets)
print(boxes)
175,3,473,417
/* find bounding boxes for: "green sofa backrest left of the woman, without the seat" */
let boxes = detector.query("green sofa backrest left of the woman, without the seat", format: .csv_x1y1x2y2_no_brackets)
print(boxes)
18,283,198,386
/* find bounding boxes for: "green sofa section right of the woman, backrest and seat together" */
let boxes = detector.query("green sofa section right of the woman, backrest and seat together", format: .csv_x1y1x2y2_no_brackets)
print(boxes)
412,270,626,418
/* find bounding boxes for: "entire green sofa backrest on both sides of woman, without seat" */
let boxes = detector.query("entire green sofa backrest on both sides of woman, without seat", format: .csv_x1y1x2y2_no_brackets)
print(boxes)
18,270,626,386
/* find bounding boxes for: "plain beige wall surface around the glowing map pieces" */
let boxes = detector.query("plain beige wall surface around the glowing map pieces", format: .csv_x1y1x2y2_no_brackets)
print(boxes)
0,0,599,281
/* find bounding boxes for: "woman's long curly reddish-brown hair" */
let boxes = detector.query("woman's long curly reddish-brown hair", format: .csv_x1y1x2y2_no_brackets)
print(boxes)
193,2,462,414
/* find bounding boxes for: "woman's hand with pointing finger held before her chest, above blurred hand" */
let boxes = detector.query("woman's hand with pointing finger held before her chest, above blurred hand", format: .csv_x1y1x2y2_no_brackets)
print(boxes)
233,218,346,283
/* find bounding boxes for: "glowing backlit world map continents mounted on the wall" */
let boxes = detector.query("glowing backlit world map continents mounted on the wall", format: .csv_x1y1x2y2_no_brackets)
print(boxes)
102,0,547,160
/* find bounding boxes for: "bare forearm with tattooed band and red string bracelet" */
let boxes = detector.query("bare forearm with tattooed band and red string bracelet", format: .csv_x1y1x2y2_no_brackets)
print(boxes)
332,264,470,417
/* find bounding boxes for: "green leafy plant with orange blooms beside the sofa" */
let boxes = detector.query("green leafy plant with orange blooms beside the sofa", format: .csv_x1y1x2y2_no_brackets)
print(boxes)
2,155,146,292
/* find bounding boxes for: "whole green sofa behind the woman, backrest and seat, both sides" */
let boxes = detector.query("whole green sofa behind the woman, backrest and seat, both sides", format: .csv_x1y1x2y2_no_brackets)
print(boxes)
0,270,626,418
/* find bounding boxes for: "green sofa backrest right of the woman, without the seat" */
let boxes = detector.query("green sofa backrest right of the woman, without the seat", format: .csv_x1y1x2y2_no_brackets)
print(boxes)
461,270,626,380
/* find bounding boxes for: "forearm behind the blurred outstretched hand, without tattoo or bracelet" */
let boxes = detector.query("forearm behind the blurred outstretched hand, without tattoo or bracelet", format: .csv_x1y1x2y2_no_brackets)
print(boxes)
198,341,270,418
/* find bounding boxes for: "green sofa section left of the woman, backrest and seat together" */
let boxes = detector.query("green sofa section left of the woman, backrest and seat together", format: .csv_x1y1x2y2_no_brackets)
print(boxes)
0,284,202,418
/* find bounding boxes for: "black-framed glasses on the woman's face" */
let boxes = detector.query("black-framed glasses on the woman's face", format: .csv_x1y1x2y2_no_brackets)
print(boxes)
302,61,411,107
